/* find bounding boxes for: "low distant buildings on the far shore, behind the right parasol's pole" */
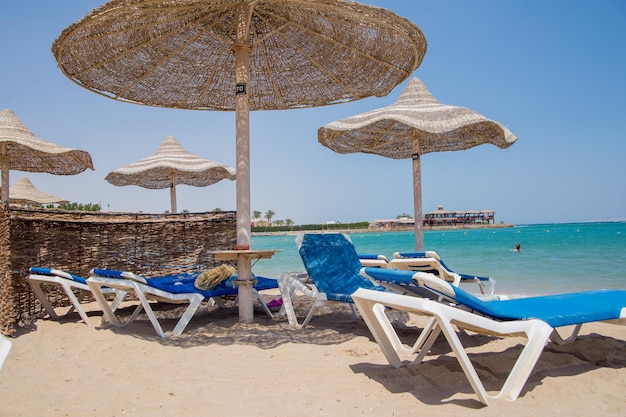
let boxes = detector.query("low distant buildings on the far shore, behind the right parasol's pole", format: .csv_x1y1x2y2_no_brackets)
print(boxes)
369,206,496,230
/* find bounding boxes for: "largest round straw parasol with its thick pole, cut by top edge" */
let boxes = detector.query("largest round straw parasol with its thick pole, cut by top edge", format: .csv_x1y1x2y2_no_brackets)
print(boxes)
52,0,426,323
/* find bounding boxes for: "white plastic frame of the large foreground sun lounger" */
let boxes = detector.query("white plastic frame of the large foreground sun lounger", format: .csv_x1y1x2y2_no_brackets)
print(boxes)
352,289,626,405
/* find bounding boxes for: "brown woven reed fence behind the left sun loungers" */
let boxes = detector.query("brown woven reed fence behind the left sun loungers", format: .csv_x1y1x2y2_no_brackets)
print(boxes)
0,208,236,335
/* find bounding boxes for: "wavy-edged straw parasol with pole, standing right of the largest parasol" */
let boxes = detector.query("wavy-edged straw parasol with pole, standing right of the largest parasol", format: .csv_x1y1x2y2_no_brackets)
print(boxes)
318,78,517,251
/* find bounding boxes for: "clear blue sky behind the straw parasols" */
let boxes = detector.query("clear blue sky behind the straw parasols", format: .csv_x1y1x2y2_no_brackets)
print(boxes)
0,0,626,224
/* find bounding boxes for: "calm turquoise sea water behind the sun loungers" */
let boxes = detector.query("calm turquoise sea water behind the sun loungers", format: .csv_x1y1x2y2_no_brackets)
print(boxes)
252,222,626,296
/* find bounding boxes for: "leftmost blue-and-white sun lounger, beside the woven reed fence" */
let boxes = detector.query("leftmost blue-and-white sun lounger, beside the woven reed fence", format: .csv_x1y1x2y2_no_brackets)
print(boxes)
26,267,131,324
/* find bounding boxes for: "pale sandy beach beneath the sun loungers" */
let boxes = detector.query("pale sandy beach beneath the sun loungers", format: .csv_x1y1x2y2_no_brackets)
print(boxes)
0,290,626,417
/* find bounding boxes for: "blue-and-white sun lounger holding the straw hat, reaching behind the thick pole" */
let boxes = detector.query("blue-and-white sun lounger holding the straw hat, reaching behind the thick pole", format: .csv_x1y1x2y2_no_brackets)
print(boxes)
87,269,278,338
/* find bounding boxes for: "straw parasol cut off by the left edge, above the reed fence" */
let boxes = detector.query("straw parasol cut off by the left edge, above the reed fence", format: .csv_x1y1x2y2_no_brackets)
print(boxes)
0,109,93,202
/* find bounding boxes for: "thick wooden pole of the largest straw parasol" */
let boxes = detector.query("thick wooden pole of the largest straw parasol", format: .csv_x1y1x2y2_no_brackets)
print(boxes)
232,3,254,323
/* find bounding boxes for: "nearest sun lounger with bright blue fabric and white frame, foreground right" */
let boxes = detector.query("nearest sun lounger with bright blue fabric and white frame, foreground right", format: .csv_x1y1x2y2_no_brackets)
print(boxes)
352,268,626,405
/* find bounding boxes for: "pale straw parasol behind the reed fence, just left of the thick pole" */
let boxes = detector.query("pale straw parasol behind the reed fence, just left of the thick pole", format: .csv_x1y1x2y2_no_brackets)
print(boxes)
105,136,235,213
